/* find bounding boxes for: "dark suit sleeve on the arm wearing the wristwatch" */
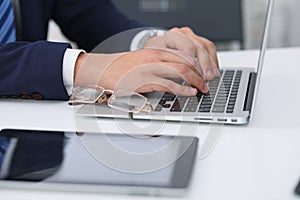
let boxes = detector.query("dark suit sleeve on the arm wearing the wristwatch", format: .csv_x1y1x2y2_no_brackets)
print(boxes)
52,0,143,52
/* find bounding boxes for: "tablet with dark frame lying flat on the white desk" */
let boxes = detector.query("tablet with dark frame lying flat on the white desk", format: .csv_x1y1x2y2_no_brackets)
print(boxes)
0,130,198,196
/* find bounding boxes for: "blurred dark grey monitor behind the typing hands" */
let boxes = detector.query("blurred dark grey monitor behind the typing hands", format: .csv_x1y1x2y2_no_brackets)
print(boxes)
112,0,243,50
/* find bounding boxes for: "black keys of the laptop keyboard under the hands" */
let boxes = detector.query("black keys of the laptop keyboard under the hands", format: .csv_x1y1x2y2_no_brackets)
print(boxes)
154,70,242,113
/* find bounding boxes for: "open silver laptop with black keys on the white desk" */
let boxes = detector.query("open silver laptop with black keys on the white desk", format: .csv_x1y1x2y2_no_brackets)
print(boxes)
77,0,274,124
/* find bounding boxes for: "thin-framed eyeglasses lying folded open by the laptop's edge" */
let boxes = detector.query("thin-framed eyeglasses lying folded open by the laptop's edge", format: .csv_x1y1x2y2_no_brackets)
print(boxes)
69,86,153,115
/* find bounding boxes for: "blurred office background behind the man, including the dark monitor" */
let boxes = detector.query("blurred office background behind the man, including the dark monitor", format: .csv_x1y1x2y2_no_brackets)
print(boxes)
48,0,300,50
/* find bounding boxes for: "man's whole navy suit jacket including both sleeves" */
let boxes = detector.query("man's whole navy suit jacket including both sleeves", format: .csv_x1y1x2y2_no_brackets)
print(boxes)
0,0,141,100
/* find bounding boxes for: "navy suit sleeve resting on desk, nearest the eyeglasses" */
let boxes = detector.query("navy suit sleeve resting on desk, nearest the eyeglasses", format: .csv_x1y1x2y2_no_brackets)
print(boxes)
0,41,69,100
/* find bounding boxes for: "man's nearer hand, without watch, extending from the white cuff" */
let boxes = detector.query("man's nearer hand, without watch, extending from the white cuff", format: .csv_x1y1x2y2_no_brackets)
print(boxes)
75,48,208,96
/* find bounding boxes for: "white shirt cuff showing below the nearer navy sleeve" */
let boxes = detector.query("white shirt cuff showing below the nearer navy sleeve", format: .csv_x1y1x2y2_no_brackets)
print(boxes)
62,49,85,95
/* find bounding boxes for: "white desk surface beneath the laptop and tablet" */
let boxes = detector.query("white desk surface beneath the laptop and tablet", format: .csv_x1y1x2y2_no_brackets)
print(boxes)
0,48,300,200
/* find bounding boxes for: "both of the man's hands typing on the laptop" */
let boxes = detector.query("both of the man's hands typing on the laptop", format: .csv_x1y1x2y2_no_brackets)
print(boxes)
75,28,220,96
